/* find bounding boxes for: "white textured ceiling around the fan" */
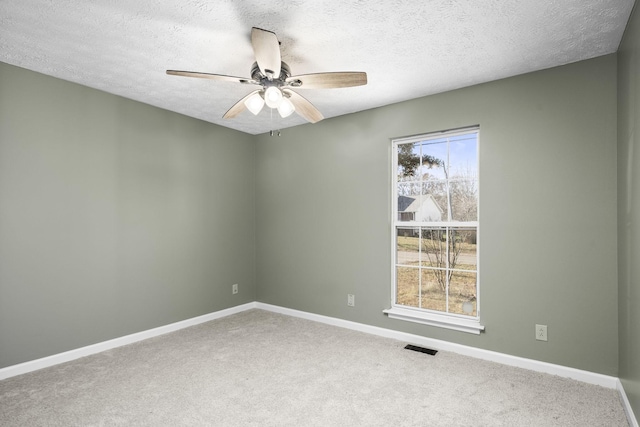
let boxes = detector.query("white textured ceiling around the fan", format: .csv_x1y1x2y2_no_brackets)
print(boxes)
0,0,634,134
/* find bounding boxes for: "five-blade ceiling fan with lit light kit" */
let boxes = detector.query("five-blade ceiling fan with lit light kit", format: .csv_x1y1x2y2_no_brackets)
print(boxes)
167,27,367,123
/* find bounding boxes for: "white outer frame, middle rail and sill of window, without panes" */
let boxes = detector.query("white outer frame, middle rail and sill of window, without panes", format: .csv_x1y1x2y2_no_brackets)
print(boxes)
384,125,484,334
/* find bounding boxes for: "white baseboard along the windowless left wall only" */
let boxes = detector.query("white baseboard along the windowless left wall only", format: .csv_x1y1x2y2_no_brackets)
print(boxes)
0,302,256,380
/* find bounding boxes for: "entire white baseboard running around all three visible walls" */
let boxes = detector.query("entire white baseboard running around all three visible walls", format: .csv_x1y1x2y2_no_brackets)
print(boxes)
0,302,640,427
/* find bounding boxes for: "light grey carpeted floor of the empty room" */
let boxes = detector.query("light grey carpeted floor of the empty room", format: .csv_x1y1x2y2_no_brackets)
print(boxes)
0,310,628,427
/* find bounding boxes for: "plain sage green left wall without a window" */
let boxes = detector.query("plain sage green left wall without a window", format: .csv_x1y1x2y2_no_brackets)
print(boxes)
0,63,256,368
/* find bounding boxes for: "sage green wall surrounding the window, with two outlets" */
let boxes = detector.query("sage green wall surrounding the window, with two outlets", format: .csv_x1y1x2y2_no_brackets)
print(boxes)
256,55,618,375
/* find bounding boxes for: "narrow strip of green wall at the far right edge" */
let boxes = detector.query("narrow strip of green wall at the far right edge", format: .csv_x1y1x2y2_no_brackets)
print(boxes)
618,1,640,417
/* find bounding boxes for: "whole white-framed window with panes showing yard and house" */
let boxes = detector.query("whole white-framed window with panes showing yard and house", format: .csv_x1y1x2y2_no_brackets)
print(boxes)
385,127,483,333
